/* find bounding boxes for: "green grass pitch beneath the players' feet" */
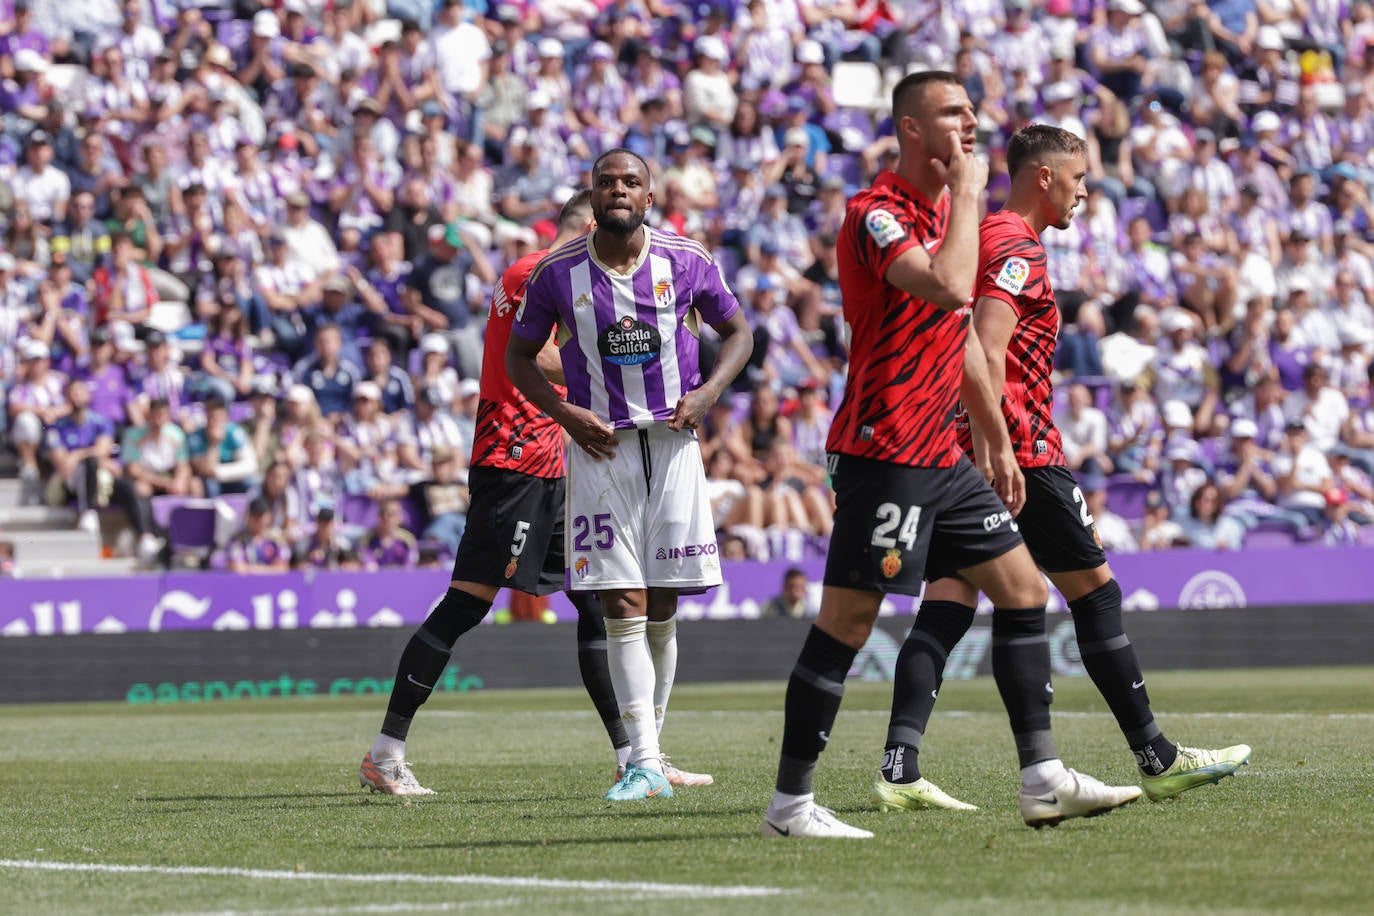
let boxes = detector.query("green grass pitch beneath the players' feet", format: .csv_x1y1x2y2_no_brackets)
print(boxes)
0,667,1374,916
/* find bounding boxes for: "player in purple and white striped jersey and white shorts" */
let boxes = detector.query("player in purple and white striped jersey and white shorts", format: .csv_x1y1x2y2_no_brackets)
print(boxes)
506,150,753,801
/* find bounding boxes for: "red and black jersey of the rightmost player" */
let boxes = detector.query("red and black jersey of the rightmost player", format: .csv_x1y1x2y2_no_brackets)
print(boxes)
965,210,1063,467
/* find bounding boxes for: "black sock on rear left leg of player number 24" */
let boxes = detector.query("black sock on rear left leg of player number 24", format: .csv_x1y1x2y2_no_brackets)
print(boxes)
776,625,859,795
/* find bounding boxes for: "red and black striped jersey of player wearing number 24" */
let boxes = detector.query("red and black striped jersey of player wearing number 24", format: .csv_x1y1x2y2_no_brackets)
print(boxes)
826,172,969,467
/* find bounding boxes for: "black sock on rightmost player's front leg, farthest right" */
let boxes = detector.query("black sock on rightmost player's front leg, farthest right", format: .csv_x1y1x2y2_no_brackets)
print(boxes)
1069,580,1178,776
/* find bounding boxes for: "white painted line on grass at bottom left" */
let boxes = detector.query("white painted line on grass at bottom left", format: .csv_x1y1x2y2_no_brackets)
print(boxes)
0,858,786,897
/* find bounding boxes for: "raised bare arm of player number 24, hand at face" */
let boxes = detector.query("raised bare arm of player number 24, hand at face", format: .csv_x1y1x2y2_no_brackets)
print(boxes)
883,130,988,312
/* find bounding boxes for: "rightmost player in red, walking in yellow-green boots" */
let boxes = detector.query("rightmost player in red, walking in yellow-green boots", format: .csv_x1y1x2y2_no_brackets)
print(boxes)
874,124,1250,809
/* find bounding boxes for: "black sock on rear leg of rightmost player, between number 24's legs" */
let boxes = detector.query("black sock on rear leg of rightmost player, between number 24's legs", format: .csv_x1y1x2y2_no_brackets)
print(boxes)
882,602,974,783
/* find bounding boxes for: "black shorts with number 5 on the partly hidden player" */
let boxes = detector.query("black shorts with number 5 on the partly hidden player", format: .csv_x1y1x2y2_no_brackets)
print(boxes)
453,467,566,595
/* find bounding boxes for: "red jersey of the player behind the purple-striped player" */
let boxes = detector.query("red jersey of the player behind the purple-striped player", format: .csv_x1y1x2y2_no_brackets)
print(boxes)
471,250,565,478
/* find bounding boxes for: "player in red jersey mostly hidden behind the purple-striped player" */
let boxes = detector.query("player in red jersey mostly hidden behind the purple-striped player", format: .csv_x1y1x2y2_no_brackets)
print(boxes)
359,191,648,795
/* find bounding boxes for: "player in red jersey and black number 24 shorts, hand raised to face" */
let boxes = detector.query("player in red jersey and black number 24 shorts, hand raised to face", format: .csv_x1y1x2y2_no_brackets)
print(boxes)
763,71,1140,839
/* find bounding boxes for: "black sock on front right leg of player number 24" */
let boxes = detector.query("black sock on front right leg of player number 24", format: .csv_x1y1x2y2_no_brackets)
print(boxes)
992,607,1059,769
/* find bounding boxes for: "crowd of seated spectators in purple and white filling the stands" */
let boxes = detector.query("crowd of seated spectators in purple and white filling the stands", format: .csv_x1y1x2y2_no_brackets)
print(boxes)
0,0,1374,569
